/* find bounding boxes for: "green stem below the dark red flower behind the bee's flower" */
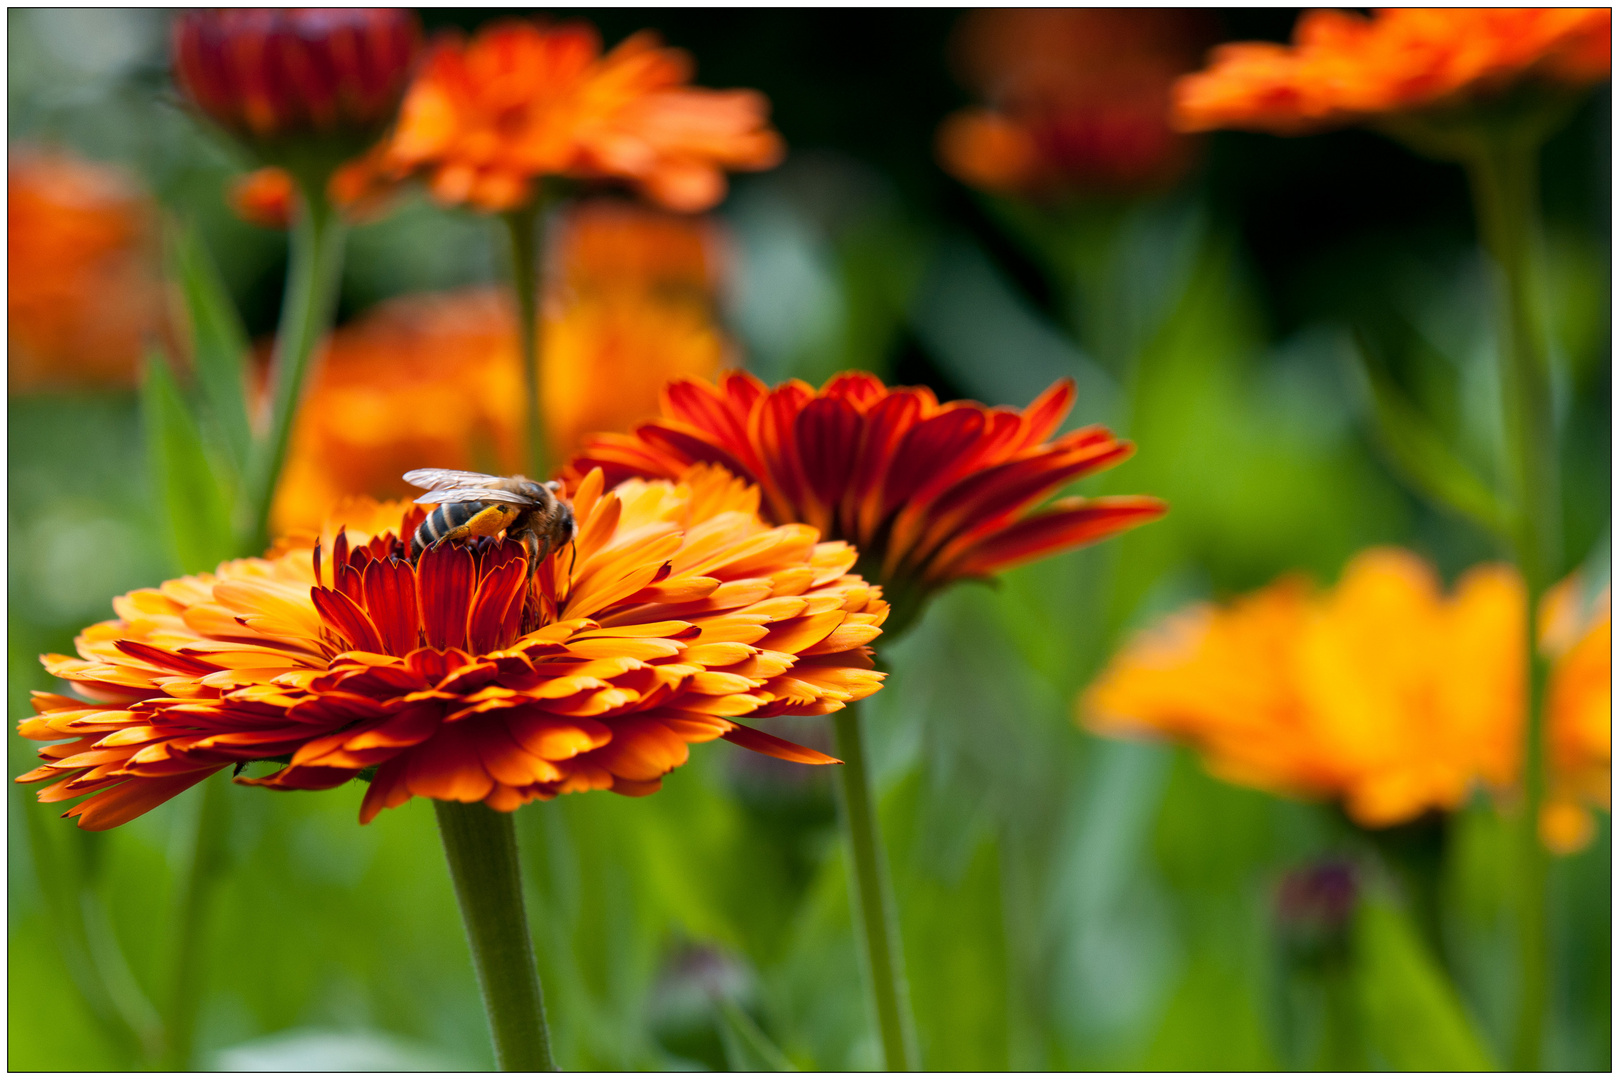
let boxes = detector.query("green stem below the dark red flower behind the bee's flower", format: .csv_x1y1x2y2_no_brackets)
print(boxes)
832,704,916,1072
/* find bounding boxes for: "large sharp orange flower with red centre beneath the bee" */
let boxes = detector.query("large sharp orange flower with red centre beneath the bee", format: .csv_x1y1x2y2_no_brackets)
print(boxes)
19,470,887,829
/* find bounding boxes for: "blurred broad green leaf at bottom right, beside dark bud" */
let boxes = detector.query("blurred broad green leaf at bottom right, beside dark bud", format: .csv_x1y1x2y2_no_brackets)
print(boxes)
1353,899,1496,1072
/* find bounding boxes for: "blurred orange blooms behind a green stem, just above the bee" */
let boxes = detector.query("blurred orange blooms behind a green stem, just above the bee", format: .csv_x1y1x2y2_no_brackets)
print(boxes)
274,202,729,529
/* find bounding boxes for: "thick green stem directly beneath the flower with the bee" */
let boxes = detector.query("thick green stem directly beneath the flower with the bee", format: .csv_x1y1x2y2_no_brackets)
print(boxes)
434,801,557,1072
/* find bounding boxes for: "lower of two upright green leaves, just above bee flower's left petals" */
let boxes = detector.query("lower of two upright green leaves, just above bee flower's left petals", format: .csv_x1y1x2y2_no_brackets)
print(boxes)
141,350,238,573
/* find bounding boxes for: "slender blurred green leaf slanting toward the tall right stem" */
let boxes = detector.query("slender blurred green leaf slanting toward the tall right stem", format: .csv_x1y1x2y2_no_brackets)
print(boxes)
1355,342,1511,536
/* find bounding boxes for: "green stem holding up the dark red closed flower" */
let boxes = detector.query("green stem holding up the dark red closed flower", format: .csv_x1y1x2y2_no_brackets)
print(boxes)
243,178,345,552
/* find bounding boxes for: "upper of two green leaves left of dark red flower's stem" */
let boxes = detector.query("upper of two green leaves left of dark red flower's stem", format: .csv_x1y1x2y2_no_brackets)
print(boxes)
173,227,253,478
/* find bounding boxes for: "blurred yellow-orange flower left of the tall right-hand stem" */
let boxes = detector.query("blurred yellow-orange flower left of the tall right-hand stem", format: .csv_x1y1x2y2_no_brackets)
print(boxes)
1080,549,1527,827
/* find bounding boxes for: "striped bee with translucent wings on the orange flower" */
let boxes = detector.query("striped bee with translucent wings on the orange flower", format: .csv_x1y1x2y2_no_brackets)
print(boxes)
405,470,580,567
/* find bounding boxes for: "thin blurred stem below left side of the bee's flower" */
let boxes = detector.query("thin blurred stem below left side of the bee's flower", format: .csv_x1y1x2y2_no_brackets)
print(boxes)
164,772,230,1069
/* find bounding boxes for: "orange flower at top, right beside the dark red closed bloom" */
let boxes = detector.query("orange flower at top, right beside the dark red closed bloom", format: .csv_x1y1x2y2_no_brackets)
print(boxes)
389,21,782,212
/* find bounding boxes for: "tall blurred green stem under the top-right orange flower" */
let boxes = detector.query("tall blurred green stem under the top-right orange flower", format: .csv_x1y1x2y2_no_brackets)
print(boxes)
1467,134,1562,1070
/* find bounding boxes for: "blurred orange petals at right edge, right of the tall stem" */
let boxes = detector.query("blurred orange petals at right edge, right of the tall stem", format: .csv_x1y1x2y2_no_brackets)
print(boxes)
1540,578,1613,852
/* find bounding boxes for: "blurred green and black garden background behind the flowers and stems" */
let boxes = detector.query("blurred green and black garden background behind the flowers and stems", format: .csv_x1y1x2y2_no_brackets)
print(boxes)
6,8,1613,1070
